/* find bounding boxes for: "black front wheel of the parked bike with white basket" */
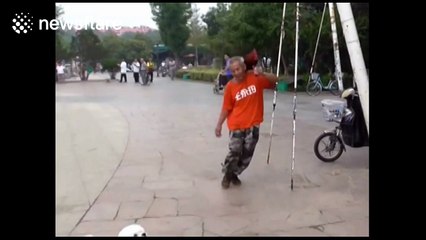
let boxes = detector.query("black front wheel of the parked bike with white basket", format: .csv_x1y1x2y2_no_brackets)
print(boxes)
314,132,343,162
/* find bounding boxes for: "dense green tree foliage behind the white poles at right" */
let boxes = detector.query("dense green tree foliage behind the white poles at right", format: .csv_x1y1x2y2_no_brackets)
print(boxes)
202,3,369,72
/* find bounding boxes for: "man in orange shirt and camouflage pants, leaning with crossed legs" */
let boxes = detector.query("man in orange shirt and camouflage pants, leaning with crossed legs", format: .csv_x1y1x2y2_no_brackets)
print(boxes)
215,57,278,189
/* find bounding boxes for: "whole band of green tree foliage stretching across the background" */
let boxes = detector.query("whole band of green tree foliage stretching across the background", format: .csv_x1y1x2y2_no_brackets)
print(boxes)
56,3,369,74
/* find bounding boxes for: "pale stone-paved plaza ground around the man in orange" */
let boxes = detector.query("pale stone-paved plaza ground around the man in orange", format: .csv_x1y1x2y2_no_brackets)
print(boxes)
56,74,369,236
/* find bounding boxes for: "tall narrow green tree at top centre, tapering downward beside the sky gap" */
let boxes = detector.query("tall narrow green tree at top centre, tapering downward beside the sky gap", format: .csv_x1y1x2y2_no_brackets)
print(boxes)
151,3,192,57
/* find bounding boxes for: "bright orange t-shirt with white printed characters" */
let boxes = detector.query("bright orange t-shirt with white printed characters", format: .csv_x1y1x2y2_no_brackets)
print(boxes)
222,73,275,131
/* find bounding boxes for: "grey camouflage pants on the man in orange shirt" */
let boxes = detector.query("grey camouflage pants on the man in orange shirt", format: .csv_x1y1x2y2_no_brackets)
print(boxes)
222,126,259,175
